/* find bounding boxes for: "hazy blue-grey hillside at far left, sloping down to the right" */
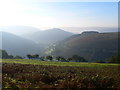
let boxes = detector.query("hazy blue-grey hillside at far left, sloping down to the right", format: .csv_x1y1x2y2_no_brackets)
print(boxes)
0,32,42,56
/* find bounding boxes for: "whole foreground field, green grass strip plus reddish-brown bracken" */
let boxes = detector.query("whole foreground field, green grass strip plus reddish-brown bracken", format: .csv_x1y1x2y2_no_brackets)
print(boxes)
2,59,120,89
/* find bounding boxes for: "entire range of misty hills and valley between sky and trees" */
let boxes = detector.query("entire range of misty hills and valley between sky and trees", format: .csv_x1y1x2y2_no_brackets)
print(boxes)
0,27,120,62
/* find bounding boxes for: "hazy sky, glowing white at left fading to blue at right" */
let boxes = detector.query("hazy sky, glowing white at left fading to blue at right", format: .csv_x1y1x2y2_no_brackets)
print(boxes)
0,0,118,28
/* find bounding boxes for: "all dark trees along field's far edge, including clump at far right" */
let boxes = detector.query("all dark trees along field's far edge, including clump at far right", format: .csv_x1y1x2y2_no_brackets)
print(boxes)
0,50,120,63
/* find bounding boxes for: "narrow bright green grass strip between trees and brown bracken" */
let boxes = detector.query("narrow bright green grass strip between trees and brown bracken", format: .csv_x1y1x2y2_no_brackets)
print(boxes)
0,59,120,67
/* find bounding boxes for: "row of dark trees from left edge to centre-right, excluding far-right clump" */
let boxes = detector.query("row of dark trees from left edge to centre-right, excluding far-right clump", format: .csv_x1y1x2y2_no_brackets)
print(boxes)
0,50,87,62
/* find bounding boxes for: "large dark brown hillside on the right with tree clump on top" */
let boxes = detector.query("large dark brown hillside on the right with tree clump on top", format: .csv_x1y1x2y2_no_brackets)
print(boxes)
46,32,120,61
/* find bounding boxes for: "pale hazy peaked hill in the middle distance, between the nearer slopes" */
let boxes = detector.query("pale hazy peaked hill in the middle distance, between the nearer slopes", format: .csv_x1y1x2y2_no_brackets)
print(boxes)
24,28,73,46
